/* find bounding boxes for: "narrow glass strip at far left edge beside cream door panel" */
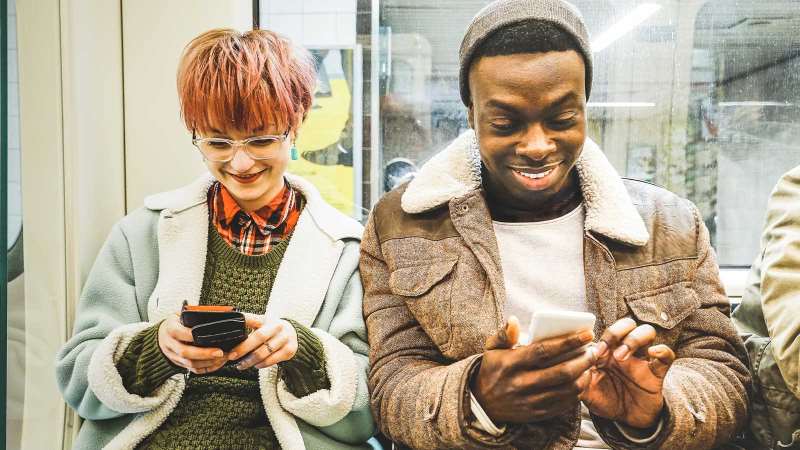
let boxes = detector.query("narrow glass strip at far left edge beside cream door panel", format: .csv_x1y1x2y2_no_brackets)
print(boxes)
2,0,25,449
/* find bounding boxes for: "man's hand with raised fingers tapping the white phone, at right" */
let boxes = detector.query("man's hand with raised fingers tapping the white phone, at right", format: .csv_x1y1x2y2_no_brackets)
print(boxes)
580,317,675,428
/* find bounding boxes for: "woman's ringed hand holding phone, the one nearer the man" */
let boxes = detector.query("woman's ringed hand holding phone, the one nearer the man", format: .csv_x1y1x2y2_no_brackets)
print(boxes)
228,314,297,370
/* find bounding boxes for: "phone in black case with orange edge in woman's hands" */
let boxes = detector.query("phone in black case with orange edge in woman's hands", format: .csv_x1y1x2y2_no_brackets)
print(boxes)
181,301,247,352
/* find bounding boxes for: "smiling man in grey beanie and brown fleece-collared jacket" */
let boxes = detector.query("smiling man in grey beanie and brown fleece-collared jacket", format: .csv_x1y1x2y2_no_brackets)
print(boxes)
360,0,749,449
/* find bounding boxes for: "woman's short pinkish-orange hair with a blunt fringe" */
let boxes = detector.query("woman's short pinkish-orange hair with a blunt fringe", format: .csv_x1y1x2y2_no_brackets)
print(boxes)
178,29,316,132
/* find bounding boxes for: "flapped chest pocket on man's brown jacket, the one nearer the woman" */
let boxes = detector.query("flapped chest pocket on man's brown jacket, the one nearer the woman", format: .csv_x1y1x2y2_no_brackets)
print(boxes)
389,258,458,351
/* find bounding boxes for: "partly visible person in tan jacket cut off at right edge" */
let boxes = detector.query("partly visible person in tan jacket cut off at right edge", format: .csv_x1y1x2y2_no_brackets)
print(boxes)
733,166,800,448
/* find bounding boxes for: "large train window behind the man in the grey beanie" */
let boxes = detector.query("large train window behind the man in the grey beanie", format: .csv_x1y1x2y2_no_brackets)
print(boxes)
374,0,800,266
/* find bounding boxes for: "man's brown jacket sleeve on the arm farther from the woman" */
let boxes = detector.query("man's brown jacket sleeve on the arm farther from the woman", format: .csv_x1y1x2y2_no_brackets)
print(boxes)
593,206,750,450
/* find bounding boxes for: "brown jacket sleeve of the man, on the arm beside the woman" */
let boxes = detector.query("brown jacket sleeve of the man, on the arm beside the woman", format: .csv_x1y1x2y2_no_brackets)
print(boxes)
361,213,518,449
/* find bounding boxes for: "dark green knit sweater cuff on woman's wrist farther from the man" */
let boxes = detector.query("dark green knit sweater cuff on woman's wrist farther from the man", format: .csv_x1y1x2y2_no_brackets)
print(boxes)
117,322,184,396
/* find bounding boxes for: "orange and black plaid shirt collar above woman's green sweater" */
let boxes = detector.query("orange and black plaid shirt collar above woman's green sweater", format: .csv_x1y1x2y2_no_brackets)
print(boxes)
207,181,304,256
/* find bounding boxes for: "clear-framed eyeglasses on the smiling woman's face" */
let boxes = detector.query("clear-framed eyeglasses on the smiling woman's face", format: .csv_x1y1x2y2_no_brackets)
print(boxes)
192,130,289,162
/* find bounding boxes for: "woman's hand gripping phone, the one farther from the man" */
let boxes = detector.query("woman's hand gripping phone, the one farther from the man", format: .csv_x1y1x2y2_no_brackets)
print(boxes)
158,314,228,374
